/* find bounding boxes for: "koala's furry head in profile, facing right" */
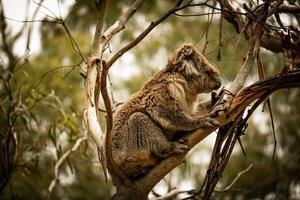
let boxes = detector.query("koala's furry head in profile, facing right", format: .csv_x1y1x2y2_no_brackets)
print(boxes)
169,44,221,93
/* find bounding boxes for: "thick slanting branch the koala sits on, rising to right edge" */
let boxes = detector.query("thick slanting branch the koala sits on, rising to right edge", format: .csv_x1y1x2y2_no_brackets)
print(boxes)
112,69,300,199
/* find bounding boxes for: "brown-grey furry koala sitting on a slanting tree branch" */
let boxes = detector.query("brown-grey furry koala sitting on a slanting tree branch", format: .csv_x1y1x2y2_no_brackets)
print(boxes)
111,44,221,179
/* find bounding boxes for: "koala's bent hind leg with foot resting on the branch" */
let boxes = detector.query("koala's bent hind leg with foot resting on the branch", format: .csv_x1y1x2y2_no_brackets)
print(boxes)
127,112,189,157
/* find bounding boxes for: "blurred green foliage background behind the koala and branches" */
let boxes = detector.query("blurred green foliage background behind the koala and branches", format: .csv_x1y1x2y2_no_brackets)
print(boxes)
0,0,300,200
